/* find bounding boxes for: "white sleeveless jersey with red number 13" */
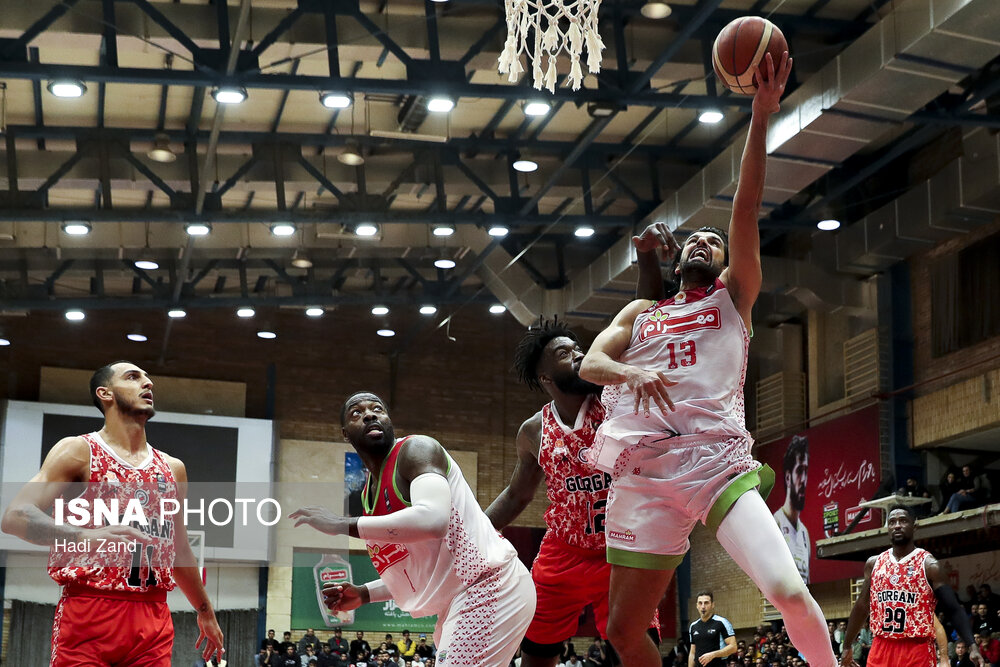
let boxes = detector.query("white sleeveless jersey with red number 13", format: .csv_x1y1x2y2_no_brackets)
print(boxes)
592,279,750,472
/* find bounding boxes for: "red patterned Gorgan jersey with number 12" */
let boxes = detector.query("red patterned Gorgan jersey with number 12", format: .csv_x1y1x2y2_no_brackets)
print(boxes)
538,396,611,551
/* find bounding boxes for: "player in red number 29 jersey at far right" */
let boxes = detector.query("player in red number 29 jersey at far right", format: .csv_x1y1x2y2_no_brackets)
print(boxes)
840,505,983,667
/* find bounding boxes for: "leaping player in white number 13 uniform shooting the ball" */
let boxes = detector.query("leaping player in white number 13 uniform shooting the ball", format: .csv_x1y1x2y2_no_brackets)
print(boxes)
580,53,836,667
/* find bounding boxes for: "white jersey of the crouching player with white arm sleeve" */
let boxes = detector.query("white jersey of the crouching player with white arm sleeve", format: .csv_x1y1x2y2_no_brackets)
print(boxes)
362,438,517,617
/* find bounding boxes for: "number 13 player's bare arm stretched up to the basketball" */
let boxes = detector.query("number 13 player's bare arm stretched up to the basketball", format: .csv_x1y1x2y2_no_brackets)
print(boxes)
722,51,792,328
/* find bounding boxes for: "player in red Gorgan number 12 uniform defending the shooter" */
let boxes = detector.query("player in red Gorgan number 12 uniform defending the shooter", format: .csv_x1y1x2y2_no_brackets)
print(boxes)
486,223,677,667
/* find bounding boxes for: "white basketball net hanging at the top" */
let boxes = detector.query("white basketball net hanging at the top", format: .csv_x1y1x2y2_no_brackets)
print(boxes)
499,0,604,93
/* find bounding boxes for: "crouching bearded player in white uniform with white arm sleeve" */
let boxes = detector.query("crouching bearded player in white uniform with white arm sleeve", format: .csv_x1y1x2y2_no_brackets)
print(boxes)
289,392,535,667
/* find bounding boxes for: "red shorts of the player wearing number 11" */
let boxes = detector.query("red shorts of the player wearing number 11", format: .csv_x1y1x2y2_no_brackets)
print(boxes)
51,586,174,667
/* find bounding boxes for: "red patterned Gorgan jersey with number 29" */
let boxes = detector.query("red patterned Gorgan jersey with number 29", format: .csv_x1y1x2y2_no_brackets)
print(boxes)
869,549,937,639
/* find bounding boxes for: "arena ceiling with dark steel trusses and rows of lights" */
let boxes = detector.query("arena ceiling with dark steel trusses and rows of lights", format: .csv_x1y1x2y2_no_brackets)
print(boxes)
0,0,1000,334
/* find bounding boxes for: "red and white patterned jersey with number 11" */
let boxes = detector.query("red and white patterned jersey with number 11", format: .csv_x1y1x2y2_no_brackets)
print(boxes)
48,433,177,593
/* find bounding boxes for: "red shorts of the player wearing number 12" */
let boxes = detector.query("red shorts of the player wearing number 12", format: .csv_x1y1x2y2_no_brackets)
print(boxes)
525,534,611,644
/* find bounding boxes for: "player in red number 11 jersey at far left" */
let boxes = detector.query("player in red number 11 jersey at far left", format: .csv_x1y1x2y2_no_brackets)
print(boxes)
0,361,224,667
